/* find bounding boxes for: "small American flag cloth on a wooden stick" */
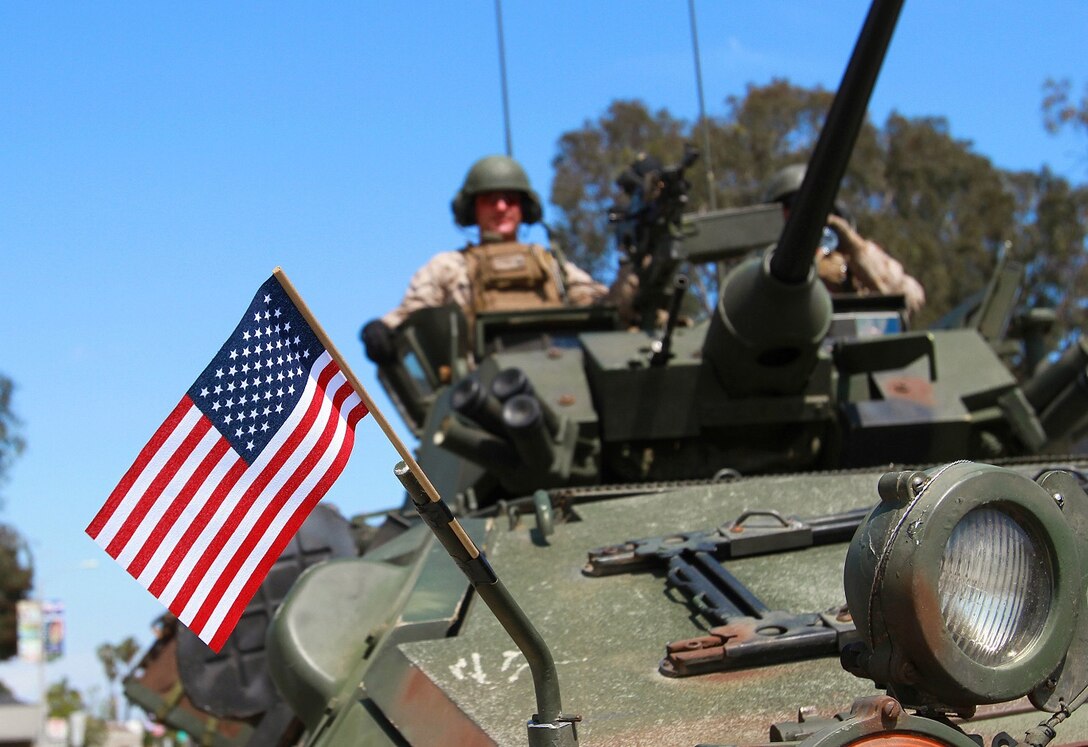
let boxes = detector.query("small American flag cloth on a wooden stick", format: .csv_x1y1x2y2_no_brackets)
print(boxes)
87,275,367,651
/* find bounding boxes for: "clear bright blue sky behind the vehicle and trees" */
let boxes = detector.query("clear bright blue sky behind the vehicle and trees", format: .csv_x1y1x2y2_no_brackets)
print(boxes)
0,0,1088,699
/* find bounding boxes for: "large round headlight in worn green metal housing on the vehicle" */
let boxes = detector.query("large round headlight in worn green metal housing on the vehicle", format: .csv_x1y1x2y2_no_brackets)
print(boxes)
843,462,1088,711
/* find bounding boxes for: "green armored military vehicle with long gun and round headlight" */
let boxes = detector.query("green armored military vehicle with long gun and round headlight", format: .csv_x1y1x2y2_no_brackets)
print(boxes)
126,0,1088,747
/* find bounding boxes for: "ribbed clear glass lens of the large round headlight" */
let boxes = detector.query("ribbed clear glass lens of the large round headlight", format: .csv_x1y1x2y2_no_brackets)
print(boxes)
938,505,1053,667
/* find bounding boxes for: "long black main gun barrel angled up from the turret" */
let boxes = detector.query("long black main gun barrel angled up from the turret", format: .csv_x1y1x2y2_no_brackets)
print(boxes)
770,0,903,285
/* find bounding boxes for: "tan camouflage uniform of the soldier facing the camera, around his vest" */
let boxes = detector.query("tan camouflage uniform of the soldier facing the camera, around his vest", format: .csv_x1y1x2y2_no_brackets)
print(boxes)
382,245,608,327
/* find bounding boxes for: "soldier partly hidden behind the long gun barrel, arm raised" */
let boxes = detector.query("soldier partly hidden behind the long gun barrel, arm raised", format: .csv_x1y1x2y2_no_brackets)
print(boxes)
765,163,926,313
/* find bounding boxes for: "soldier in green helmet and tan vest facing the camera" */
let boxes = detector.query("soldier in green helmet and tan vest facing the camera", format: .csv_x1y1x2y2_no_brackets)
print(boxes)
362,155,607,363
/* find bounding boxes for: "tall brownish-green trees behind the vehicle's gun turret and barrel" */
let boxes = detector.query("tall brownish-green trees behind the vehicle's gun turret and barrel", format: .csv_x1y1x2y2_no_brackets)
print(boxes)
551,79,1088,340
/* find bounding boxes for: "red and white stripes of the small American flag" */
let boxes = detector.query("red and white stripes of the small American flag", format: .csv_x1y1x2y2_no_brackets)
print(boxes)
87,352,367,651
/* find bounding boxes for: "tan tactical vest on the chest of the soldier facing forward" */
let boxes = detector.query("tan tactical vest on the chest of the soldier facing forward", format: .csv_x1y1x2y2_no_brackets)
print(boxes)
463,241,564,315
